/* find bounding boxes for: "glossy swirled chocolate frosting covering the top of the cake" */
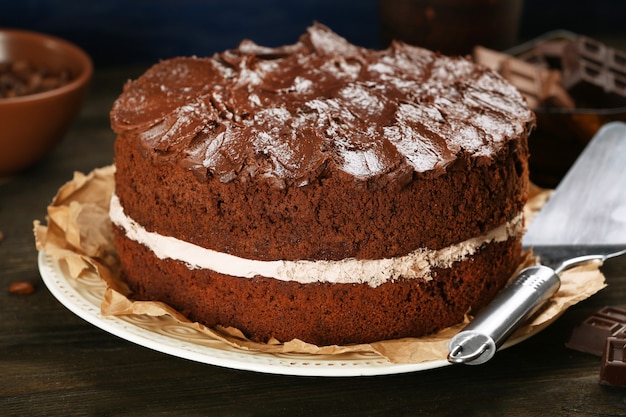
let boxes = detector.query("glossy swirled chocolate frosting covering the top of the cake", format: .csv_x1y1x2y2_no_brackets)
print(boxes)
111,24,534,188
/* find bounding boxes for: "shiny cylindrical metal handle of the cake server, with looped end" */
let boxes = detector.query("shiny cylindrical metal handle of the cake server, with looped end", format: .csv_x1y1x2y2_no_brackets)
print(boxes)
448,265,561,365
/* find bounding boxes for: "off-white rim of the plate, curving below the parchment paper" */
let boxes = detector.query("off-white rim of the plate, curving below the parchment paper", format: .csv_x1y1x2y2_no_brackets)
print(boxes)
37,250,454,377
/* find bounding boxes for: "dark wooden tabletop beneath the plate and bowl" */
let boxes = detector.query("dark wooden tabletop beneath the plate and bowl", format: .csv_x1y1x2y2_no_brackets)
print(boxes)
0,68,626,417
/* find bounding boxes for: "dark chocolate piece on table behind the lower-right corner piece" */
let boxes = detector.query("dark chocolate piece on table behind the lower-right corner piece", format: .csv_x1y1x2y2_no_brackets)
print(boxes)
565,307,626,356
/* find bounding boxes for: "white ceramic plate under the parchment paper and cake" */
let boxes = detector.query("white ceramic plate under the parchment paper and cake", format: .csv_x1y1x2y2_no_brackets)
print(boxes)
39,251,525,377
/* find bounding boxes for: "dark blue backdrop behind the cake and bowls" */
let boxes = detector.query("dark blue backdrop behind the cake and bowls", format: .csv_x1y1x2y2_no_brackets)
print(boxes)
0,0,626,66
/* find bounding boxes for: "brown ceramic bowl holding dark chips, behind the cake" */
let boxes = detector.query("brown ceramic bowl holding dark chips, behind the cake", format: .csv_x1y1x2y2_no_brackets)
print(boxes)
0,29,93,178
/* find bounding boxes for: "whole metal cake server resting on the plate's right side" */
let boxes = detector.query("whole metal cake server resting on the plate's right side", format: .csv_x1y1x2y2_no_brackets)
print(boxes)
448,122,626,365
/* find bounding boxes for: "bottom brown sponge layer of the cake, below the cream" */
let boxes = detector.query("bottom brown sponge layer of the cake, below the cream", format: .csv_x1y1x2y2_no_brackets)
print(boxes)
114,228,521,345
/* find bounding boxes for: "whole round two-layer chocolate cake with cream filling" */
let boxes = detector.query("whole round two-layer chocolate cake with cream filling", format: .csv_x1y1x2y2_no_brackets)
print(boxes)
111,24,534,345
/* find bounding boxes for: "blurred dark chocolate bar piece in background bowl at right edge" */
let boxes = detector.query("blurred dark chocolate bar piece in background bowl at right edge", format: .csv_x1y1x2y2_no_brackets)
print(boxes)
562,36,626,108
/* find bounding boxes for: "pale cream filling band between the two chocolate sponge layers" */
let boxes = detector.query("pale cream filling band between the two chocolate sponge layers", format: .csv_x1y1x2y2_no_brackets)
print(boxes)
109,193,524,287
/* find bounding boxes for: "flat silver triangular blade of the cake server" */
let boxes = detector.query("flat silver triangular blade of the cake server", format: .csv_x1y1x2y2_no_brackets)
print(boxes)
523,118,626,262
